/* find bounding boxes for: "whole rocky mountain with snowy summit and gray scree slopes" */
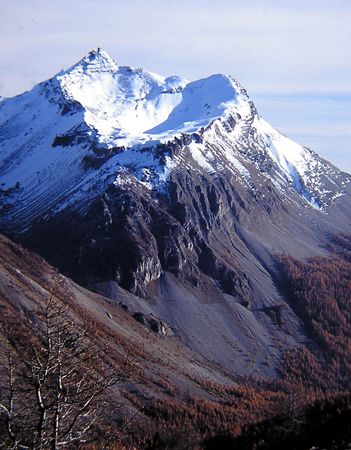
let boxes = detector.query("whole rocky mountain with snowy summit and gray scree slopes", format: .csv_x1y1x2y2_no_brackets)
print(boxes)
0,49,351,377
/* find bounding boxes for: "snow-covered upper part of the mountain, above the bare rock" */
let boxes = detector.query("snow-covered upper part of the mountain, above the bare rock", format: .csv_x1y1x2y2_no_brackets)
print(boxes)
0,49,350,231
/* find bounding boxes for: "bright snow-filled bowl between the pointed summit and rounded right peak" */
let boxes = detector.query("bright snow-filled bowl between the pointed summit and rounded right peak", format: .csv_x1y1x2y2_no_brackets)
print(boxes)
57,49,242,146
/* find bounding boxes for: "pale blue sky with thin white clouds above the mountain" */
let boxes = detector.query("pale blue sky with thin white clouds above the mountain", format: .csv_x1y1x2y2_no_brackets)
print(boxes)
0,0,351,172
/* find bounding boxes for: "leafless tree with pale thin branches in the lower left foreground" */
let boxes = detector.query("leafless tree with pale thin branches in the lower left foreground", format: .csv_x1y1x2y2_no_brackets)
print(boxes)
0,280,133,449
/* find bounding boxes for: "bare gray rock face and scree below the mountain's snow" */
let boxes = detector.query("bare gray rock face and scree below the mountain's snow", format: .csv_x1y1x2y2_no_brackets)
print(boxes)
17,137,348,376
